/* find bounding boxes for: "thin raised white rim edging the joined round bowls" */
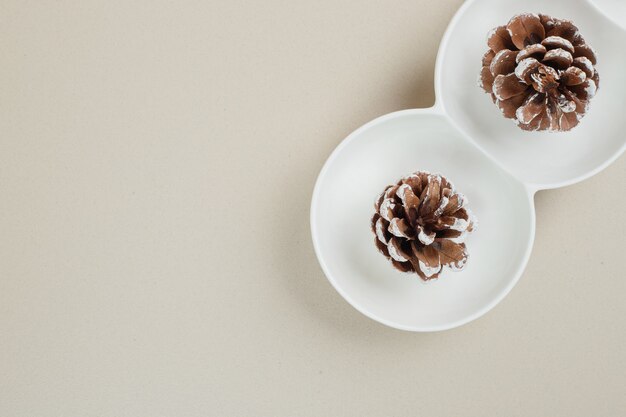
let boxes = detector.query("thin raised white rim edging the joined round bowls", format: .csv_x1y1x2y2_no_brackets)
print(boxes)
310,0,626,332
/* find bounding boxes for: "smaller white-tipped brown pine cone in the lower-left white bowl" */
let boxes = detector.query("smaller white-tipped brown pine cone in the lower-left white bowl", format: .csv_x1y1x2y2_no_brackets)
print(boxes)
372,172,474,281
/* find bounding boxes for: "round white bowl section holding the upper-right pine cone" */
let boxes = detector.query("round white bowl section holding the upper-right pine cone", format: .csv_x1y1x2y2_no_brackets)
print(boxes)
435,0,626,189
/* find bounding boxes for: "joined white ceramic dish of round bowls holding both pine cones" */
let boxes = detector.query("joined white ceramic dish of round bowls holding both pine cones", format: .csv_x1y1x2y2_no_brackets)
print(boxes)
311,0,626,331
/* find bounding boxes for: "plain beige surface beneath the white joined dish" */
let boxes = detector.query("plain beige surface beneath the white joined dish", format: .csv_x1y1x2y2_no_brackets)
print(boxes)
0,0,626,417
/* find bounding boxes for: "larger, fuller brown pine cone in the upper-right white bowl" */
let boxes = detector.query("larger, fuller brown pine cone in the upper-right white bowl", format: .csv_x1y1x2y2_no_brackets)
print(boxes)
480,14,600,131
